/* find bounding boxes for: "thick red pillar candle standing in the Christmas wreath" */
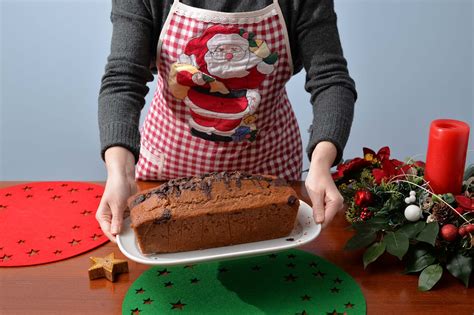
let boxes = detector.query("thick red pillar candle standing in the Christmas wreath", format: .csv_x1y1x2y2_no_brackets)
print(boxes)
425,119,469,194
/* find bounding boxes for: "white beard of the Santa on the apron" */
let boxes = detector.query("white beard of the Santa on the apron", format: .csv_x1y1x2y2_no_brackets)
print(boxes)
204,51,261,79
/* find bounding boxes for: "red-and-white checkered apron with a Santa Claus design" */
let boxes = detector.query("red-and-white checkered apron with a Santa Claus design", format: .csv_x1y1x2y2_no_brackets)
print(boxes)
136,0,302,180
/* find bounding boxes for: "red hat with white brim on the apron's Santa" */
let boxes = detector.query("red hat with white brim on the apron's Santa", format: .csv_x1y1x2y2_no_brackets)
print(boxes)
184,25,244,67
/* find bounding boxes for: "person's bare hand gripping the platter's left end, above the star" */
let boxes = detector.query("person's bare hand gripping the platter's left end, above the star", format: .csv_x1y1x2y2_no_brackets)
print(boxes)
95,147,137,243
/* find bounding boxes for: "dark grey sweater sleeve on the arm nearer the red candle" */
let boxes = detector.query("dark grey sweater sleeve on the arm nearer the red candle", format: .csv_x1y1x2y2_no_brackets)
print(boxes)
296,0,357,165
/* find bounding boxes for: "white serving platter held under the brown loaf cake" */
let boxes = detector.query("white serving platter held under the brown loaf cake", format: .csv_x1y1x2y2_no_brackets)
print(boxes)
117,201,321,266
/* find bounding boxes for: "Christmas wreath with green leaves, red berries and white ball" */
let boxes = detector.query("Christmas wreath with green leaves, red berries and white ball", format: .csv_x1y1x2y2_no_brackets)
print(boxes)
333,147,474,291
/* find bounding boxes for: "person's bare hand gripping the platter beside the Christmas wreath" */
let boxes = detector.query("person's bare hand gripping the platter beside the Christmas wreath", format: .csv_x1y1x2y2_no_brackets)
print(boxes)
305,141,344,228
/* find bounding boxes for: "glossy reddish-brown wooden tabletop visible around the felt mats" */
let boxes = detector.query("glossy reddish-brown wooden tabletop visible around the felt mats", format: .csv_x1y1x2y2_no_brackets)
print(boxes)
0,182,474,315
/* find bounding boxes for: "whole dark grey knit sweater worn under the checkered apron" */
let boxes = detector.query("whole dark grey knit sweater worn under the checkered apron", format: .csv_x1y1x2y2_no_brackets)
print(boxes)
99,0,356,167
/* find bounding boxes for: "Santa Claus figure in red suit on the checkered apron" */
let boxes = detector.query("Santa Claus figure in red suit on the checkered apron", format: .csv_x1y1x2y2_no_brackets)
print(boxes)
168,25,278,142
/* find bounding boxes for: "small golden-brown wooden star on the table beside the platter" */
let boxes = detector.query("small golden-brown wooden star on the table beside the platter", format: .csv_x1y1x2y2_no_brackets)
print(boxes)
89,253,128,282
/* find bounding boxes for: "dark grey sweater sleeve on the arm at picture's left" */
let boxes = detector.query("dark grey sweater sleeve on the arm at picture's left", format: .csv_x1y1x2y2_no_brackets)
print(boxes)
98,0,153,161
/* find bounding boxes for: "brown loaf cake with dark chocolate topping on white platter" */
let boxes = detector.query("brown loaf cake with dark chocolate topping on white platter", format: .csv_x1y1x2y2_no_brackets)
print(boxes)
128,172,299,254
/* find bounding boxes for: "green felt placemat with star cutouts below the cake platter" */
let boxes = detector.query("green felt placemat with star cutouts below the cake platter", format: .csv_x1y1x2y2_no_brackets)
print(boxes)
122,250,366,315
